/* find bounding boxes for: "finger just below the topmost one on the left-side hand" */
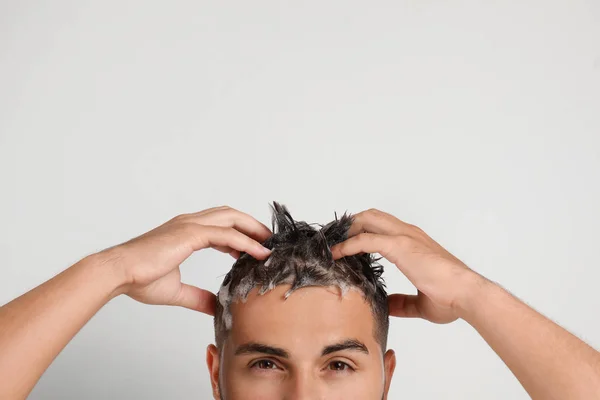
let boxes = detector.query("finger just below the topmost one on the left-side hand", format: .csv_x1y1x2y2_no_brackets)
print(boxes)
183,223,271,260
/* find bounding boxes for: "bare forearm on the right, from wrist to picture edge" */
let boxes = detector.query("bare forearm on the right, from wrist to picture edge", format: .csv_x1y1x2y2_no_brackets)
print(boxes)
461,280,600,399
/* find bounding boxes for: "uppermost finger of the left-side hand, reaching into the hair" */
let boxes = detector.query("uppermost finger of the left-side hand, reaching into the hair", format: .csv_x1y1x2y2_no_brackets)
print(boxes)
192,207,273,242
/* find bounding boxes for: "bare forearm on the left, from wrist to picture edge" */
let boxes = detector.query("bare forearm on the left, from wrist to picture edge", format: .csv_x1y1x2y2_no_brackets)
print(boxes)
0,255,122,399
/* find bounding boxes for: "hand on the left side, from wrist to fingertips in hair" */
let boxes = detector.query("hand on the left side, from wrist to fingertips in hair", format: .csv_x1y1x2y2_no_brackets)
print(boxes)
102,206,271,315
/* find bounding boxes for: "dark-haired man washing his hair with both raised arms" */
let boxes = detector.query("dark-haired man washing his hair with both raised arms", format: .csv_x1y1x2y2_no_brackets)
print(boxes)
0,205,600,400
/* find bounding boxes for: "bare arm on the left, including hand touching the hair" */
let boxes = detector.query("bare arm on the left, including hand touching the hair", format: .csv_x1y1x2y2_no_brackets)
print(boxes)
0,207,270,399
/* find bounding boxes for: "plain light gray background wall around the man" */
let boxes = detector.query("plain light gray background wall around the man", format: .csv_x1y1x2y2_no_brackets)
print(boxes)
0,0,600,399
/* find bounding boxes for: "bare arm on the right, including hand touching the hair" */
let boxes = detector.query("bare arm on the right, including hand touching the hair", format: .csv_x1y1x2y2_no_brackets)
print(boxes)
332,210,600,399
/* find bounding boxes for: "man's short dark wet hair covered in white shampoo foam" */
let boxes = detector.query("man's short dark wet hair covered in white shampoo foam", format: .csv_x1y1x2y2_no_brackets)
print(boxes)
214,202,389,351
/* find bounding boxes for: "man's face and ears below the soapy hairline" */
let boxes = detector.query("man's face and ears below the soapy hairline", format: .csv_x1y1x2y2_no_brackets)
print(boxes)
207,285,396,400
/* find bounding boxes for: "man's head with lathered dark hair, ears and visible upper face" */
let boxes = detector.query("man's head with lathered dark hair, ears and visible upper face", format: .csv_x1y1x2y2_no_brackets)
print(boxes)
207,203,395,400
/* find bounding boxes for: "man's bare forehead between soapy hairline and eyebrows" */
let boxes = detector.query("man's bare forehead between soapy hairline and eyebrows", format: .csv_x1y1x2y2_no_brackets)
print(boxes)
228,285,378,354
